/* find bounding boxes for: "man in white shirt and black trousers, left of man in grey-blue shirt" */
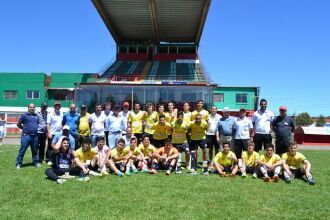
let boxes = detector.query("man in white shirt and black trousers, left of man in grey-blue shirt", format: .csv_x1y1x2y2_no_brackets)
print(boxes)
206,106,221,160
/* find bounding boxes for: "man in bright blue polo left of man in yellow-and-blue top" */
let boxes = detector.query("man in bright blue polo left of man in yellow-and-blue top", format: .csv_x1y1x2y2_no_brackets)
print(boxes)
62,104,80,150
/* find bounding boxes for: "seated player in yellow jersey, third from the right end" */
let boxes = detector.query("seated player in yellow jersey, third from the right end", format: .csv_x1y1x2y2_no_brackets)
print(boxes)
238,141,259,178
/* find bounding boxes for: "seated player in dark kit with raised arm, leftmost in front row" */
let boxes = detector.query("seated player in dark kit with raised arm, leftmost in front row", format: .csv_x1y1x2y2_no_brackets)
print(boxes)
45,136,89,184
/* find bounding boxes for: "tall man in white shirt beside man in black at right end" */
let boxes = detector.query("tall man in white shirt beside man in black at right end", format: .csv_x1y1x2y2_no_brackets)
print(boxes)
252,99,274,152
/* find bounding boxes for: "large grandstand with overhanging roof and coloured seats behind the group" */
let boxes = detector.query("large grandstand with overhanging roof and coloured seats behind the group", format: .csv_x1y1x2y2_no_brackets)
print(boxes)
76,0,212,104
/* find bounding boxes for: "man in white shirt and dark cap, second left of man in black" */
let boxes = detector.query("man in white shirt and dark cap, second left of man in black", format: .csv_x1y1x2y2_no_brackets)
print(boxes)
233,108,253,159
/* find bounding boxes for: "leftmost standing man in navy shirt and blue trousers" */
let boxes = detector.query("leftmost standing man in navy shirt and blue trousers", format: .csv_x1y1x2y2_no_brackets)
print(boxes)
16,103,40,169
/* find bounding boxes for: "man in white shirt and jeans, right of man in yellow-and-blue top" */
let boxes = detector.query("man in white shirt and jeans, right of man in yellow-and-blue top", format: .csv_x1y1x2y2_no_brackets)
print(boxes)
89,103,107,147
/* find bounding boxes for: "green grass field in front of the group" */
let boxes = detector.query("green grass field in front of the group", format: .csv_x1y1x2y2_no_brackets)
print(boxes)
0,146,330,219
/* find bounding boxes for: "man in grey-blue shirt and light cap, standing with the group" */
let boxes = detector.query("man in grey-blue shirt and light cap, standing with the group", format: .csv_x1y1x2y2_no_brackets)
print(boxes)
216,107,235,151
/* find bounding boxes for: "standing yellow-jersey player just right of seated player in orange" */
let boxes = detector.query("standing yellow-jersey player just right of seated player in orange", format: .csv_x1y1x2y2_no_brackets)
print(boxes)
172,112,190,174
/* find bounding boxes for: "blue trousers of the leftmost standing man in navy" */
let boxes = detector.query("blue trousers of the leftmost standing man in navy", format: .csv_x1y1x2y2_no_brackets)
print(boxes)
16,135,38,166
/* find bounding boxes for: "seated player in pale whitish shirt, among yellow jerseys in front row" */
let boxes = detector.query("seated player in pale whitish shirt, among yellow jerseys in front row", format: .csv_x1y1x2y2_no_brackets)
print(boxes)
91,136,123,176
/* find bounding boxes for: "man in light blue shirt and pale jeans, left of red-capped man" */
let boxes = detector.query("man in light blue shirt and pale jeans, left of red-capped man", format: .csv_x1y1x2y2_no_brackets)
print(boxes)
105,105,125,149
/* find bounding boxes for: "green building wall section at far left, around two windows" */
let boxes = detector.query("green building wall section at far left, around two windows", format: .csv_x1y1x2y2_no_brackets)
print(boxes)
0,73,46,107
